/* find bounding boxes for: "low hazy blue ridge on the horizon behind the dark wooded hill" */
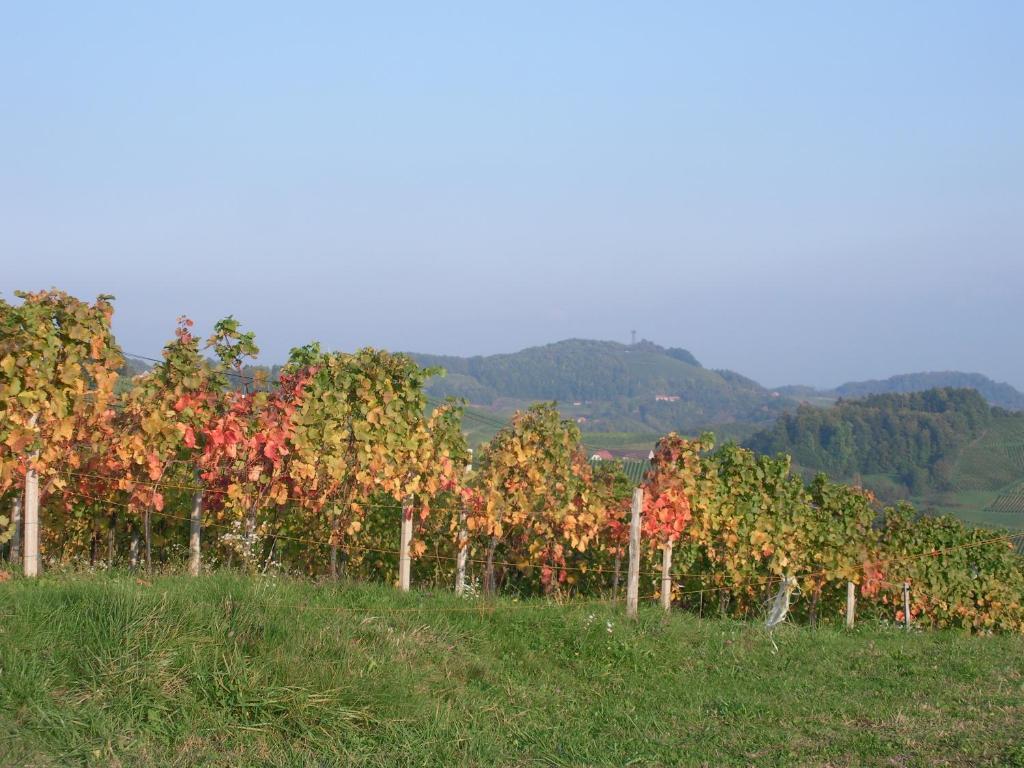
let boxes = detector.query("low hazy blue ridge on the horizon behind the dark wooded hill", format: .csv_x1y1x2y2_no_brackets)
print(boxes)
778,371,1024,411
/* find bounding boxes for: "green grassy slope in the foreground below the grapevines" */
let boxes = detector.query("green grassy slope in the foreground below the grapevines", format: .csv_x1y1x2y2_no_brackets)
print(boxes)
0,574,1024,767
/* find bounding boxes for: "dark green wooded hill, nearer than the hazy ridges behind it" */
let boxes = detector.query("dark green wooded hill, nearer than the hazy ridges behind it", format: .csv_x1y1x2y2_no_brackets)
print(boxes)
746,388,1010,494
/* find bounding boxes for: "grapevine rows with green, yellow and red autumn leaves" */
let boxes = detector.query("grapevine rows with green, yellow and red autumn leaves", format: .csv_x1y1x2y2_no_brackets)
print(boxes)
6,291,1024,632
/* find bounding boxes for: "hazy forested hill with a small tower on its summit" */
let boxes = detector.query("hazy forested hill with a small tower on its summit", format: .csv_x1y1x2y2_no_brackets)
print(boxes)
413,339,797,432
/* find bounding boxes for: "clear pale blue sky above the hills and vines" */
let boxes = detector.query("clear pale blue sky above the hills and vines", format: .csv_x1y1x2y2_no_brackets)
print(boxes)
0,1,1024,387
